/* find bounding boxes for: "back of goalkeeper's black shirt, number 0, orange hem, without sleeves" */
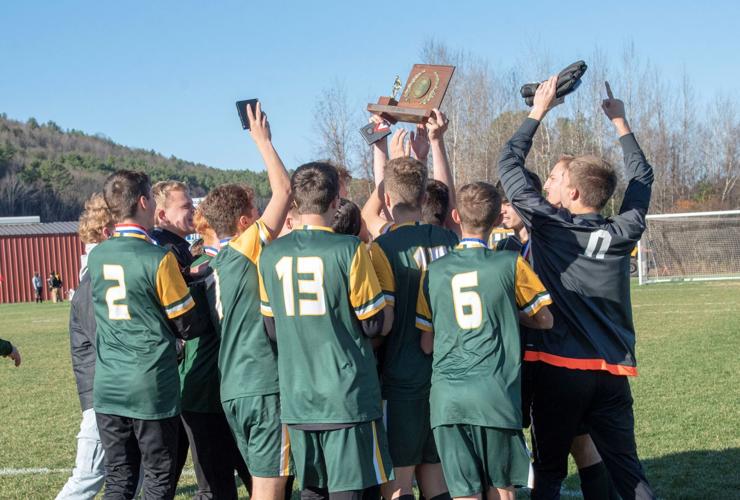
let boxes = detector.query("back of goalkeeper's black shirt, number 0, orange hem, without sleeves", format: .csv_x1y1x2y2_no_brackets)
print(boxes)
526,211,636,375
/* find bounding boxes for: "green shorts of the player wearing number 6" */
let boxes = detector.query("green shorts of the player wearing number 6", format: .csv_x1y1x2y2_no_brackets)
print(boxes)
434,424,529,498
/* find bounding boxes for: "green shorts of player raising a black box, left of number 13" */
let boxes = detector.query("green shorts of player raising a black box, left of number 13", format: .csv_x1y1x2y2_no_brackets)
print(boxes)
222,394,293,477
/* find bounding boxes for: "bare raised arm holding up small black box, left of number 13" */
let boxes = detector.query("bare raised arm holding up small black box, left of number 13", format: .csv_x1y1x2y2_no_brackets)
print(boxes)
247,102,291,238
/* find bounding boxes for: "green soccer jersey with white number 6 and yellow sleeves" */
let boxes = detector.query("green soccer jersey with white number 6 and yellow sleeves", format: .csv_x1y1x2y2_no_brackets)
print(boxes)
417,239,551,429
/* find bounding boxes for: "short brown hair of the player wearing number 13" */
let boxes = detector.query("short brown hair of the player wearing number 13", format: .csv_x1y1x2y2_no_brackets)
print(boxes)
290,162,339,215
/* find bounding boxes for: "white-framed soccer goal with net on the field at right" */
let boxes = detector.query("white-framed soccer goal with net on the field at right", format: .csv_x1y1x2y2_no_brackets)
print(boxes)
637,210,740,285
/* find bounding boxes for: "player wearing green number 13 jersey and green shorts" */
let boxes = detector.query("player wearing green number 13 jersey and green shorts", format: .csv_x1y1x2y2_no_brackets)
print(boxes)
259,163,393,500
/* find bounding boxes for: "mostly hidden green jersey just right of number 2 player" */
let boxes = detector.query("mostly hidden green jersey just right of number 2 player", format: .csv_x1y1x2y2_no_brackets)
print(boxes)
180,253,223,413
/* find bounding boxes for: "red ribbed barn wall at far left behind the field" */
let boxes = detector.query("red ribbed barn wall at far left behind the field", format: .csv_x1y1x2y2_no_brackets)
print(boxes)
0,233,85,303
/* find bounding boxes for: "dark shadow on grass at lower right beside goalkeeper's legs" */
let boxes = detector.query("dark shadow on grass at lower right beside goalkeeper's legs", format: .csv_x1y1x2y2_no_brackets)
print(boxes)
564,448,740,500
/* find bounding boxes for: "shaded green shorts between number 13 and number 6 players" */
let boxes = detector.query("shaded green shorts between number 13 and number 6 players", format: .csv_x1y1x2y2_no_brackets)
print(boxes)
383,398,439,467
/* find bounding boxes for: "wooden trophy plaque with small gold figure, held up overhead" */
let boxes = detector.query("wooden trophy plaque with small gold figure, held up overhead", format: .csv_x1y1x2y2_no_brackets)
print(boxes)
367,64,455,123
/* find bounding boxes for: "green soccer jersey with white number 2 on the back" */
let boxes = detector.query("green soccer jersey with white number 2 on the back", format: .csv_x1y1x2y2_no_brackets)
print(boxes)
87,225,195,420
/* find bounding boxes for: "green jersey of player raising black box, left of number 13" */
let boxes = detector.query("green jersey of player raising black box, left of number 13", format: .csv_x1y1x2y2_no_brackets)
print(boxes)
211,220,279,401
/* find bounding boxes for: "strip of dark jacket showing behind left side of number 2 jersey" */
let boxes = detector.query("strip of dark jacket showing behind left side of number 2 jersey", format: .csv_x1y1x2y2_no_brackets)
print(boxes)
69,272,96,411
